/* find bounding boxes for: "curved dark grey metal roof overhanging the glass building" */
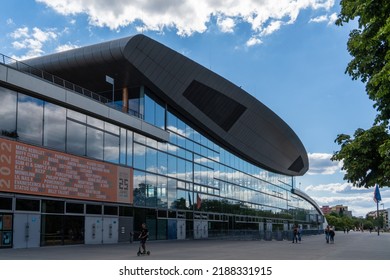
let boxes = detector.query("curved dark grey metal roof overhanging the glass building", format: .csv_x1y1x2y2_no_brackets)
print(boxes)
26,35,309,176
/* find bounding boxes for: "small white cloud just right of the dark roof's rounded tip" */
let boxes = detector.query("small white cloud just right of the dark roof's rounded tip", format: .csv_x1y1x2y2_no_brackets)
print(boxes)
307,153,342,175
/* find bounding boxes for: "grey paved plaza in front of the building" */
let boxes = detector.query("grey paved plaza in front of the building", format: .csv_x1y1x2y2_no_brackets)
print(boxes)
0,232,390,260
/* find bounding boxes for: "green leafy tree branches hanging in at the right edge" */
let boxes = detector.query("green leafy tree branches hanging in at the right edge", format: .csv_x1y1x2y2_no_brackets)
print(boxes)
332,0,390,188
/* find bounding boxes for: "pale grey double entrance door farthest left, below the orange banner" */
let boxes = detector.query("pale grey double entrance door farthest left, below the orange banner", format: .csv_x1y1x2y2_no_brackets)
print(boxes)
13,213,41,248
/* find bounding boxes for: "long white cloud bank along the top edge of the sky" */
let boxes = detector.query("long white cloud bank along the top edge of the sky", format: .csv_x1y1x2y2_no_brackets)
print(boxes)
37,0,334,42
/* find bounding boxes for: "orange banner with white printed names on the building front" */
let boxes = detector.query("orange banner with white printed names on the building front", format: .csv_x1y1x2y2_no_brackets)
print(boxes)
0,138,133,203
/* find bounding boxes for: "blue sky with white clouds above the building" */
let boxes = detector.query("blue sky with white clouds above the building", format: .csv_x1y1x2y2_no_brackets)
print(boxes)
0,0,390,216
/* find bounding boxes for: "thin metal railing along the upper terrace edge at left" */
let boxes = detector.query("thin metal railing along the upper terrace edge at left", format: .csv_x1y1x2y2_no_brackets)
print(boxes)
0,54,143,119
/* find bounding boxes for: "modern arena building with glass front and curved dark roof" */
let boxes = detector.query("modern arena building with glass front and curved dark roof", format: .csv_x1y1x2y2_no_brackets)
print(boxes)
0,35,324,248
